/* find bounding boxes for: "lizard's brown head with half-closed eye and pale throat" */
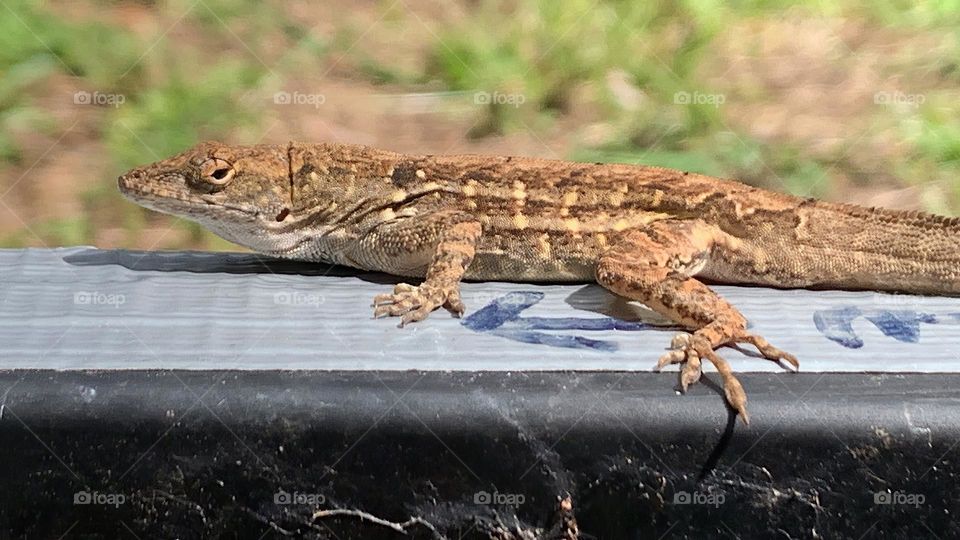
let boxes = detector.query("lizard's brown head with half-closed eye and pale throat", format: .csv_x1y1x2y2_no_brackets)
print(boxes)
117,142,290,251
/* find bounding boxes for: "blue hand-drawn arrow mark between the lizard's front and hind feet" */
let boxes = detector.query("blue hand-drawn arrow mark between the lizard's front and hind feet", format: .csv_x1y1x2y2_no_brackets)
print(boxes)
460,291,653,352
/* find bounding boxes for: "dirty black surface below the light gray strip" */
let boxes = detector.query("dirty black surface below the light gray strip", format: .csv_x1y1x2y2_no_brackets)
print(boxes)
0,371,960,539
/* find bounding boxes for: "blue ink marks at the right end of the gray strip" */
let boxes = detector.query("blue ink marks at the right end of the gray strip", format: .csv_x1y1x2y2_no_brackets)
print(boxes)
813,306,960,349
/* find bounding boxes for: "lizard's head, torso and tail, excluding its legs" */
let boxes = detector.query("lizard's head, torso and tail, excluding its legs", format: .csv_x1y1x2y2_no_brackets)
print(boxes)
119,138,960,294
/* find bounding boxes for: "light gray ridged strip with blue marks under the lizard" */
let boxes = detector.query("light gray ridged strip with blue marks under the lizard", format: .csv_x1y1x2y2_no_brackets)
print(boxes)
0,247,960,372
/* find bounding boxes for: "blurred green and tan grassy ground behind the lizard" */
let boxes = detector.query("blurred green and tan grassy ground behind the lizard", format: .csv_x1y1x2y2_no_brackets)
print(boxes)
0,0,960,249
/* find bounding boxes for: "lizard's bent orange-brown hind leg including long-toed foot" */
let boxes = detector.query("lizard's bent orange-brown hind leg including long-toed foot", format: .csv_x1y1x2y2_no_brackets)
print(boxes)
597,220,799,423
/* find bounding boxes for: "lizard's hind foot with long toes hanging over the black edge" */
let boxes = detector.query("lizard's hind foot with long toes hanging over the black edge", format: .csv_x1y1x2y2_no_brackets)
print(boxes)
654,333,800,424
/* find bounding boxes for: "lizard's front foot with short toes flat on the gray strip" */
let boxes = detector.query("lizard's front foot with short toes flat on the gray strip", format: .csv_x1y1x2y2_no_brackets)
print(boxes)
373,282,466,327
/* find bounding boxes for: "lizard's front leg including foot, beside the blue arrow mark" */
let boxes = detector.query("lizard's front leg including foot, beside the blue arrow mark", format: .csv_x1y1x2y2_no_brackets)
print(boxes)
360,211,481,326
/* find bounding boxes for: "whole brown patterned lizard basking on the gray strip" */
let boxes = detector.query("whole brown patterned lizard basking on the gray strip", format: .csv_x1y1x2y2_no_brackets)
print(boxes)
118,142,960,424
